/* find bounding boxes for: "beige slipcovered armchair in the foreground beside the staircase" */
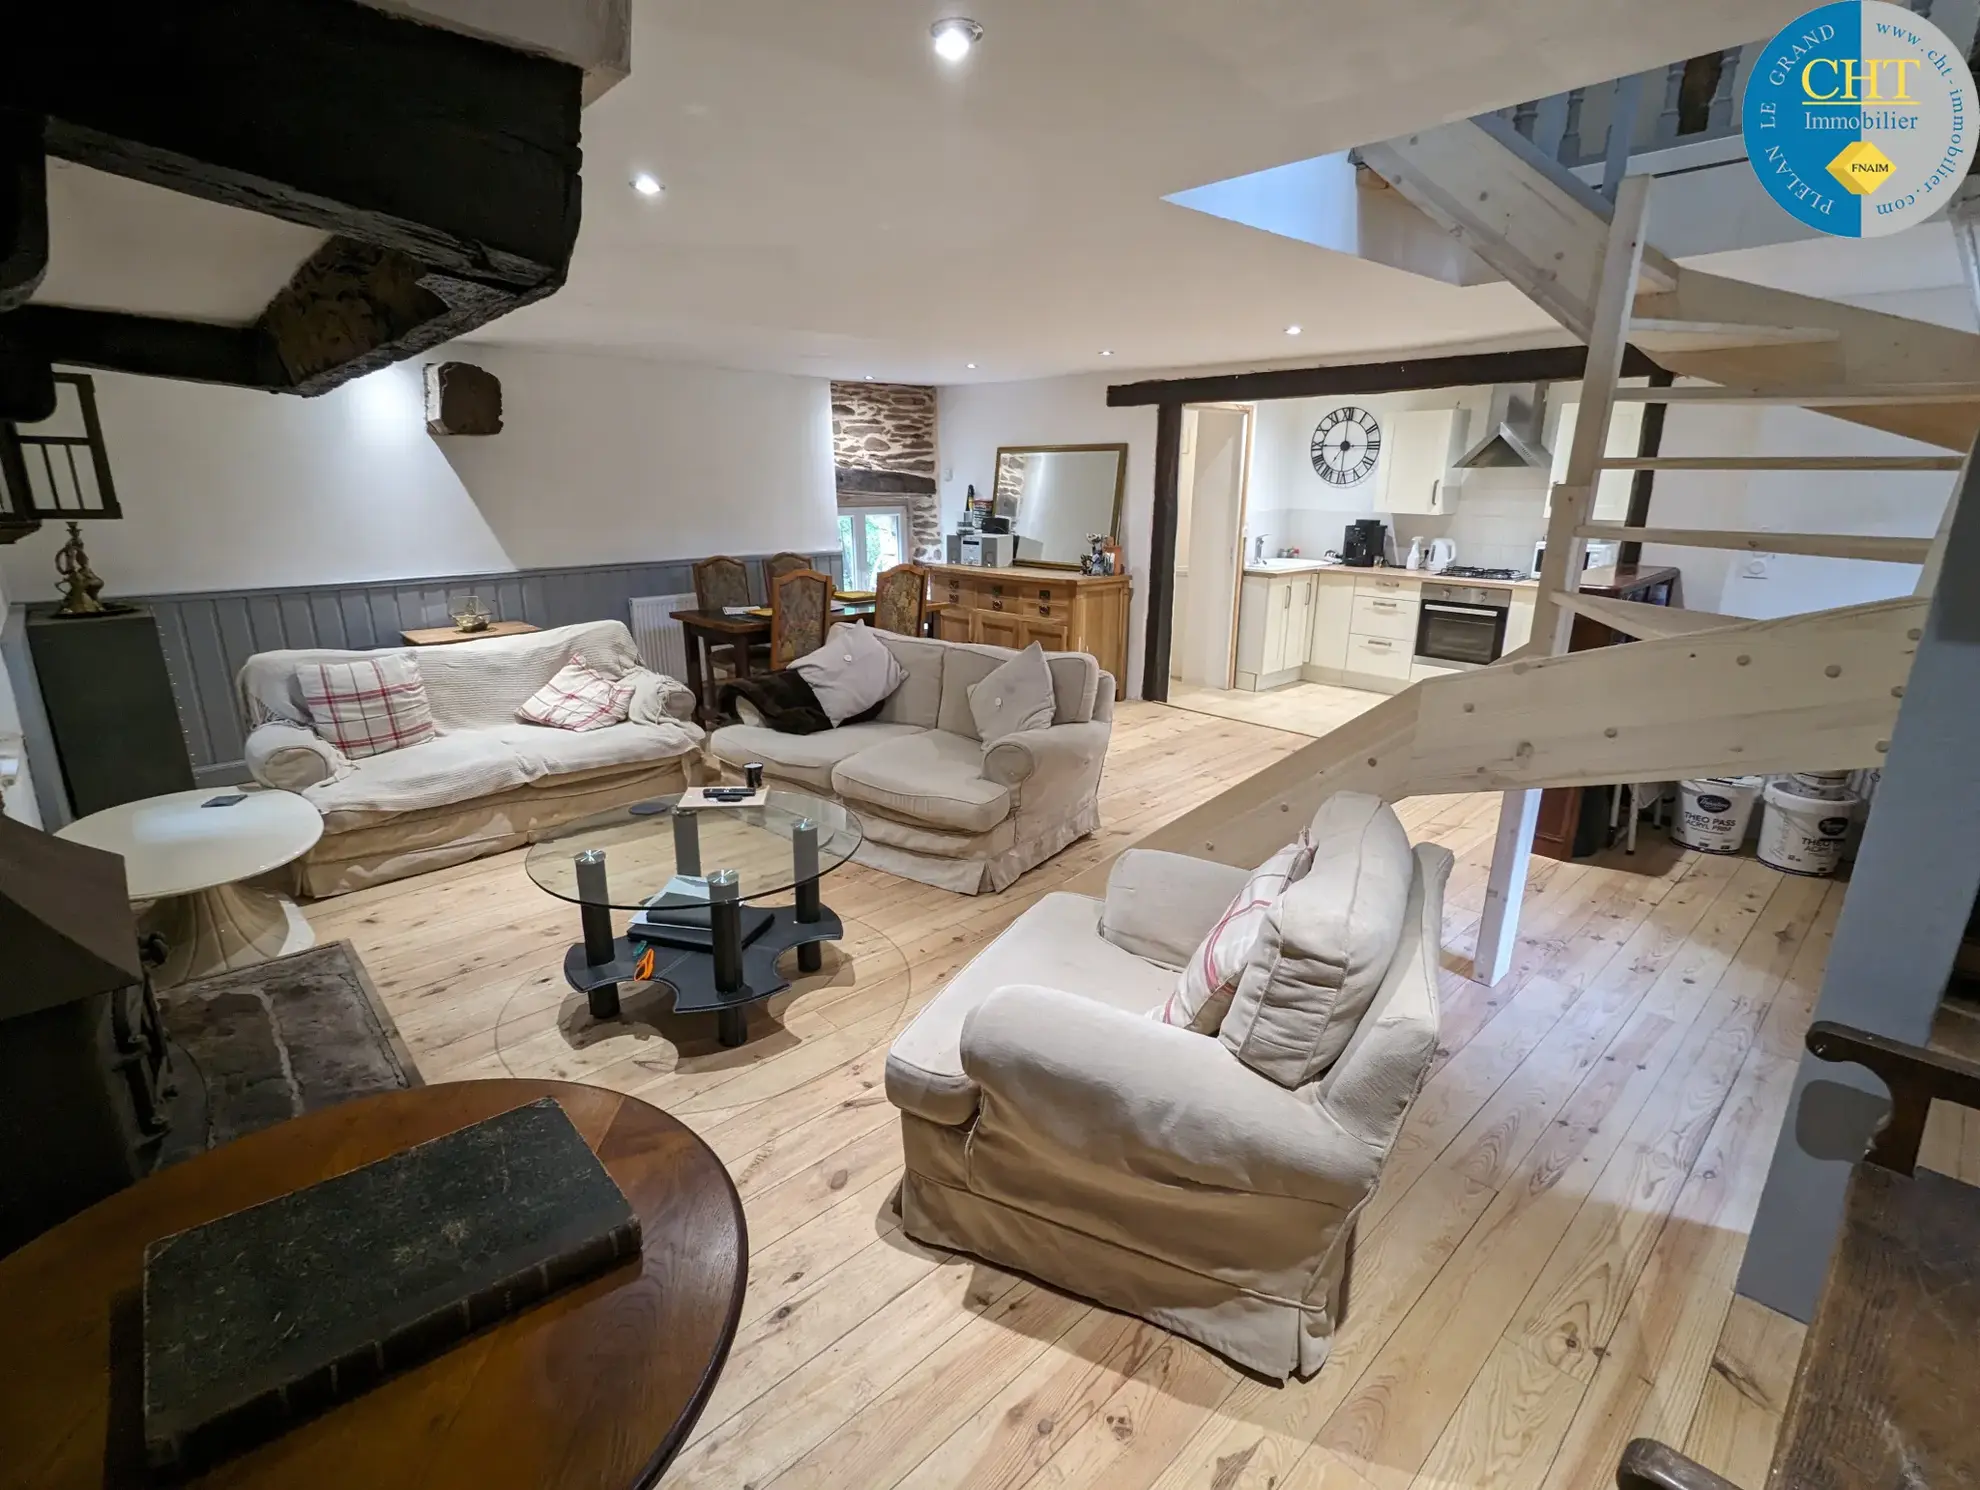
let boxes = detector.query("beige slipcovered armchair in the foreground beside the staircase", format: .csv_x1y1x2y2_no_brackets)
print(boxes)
887,793,1451,1379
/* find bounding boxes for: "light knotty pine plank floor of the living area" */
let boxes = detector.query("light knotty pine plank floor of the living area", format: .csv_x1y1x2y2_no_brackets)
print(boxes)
309,702,1841,1490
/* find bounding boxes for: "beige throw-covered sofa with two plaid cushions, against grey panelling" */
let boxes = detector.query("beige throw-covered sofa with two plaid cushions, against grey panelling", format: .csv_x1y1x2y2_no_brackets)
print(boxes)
236,621,703,896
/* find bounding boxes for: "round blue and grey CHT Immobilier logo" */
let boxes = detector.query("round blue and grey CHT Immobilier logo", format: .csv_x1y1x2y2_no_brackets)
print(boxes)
1744,0,1974,237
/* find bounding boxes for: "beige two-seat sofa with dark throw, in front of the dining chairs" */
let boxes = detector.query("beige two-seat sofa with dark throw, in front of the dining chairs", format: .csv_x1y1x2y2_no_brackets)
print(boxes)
709,631,1115,894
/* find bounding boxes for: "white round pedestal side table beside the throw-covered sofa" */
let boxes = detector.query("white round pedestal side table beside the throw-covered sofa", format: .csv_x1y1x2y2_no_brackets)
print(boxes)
55,788,323,985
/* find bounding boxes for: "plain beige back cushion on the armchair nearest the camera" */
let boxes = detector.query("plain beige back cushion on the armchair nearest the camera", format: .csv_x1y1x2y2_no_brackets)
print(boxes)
1218,792,1414,1086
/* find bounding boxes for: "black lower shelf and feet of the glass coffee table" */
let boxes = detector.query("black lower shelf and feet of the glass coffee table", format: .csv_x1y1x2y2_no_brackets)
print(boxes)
564,902,845,1047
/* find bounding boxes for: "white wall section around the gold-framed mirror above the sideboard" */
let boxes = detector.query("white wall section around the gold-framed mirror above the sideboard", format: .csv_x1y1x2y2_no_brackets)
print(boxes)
937,376,1154,697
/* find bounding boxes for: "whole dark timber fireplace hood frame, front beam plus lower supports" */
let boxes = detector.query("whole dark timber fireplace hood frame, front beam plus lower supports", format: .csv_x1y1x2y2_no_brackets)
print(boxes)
0,0,584,394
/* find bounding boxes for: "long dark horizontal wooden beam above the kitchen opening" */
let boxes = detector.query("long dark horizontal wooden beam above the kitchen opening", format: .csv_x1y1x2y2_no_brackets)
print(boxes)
1107,346,1657,408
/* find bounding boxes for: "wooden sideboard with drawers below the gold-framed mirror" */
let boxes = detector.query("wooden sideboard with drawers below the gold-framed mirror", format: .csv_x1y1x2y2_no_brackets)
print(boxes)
929,564,1131,698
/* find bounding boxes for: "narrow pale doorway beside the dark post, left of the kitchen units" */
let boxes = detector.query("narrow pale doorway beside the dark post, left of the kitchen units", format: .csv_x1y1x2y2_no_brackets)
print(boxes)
1168,404,1251,689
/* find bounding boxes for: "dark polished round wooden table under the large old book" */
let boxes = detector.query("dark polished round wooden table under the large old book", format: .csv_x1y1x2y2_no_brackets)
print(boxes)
0,1080,748,1490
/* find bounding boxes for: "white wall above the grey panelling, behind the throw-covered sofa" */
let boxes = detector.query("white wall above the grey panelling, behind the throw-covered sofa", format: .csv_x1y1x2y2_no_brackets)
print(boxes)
0,344,838,602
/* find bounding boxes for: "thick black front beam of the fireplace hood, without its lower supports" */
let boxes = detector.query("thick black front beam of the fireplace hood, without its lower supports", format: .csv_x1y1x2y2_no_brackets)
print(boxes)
0,0,584,285
